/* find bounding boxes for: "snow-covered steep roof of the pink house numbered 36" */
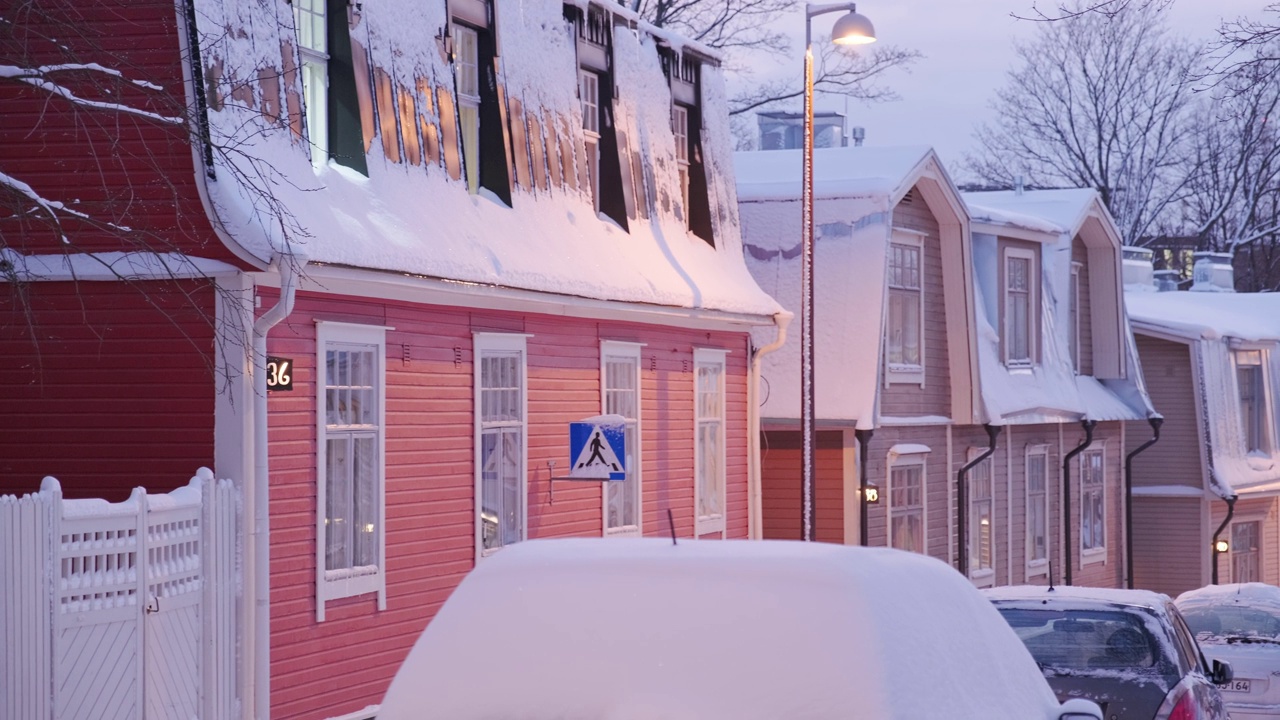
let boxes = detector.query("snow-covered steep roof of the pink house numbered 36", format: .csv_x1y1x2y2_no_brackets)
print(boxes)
195,0,780,319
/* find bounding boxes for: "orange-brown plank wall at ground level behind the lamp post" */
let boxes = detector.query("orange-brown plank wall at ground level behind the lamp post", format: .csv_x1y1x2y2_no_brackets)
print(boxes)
760,429,858,544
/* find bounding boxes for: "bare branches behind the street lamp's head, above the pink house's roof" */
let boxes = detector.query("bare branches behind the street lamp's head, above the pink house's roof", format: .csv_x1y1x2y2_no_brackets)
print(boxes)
631,0,920,115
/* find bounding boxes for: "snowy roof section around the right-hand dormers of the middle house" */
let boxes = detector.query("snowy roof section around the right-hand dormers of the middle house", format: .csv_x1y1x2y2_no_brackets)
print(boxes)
963,190,1153,424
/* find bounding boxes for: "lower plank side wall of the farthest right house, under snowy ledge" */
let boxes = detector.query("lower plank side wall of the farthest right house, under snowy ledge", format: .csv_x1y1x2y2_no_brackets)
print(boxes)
1133,496,1203,597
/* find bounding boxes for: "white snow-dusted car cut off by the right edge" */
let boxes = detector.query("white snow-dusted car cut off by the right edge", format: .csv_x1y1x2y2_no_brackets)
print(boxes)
1175,583,1280,720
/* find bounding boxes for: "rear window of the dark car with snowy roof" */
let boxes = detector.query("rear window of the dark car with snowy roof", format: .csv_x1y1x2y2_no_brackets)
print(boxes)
998,607,1160,673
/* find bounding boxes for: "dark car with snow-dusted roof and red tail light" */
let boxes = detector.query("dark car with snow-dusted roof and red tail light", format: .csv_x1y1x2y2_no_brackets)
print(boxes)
984,585,1231,720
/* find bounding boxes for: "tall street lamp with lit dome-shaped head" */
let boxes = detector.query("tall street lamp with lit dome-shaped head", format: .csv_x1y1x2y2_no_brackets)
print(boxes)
800,3,876,541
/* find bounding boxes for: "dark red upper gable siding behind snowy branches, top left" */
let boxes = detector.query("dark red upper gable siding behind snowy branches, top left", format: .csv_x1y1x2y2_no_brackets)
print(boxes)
0,0,239,263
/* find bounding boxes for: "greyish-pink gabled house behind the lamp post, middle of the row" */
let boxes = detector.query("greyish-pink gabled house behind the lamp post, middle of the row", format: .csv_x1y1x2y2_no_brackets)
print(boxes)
735,147,1152,587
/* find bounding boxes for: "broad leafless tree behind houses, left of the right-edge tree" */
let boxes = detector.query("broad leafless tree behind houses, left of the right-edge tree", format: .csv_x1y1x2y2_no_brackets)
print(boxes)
966,6,1202,243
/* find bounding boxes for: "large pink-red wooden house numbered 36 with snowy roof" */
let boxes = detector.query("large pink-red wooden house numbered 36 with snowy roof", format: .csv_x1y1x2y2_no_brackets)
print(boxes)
0,0,788,720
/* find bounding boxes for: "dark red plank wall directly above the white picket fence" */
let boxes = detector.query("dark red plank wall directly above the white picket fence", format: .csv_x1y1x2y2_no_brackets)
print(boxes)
0,280,217,502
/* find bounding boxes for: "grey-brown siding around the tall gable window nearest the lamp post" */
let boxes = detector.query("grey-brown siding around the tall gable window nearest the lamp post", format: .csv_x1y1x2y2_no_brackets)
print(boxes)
881,187,951,416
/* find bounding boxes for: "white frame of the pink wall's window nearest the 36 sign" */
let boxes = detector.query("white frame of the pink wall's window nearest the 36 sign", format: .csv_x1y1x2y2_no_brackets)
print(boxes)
316,320,384,623
